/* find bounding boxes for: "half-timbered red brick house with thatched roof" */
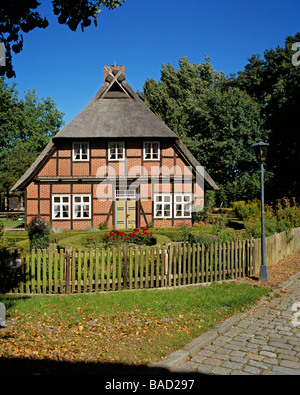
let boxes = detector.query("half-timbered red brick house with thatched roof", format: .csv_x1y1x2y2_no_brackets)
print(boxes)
12,66,218,229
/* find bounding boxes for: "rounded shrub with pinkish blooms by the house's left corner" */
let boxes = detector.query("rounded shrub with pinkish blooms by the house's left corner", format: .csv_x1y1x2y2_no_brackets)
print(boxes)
28,216,50,249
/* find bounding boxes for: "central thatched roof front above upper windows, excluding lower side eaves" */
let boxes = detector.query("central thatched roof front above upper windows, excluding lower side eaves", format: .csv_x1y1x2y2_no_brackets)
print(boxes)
53,74,178,141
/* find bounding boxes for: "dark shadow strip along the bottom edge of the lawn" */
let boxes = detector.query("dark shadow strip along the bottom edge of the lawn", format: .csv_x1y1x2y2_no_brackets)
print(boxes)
0,358,206,381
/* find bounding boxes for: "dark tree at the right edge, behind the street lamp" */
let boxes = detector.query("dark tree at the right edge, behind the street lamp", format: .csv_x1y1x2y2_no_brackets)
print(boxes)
232,33,300,197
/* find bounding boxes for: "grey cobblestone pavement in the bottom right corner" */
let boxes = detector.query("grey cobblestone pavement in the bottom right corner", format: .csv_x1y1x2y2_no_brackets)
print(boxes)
155,272,300,375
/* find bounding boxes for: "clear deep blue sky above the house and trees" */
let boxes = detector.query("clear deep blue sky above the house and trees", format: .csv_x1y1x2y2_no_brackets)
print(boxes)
10,0,300,123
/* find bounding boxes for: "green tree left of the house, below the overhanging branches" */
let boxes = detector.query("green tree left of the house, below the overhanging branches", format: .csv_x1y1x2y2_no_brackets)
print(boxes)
0,77,64,195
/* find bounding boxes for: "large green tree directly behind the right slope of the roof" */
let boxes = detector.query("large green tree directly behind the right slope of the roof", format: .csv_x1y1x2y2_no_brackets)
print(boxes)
141,58,268,204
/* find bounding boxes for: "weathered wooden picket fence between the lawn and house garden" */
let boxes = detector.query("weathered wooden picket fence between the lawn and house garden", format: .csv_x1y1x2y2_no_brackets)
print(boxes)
0,240,254,294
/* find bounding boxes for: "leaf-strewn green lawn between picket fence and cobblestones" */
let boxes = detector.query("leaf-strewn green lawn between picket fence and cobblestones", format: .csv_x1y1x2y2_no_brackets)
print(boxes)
0,283,269,365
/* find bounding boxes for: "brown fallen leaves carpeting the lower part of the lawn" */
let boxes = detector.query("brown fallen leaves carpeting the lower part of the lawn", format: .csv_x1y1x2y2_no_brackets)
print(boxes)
0,313,190,363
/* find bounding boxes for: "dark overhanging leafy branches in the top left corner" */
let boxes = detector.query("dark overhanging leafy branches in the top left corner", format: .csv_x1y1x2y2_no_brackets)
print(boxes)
0,0,125,78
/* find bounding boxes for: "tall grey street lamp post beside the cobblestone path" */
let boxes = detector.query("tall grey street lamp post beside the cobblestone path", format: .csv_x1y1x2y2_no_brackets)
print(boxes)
252,139,269,281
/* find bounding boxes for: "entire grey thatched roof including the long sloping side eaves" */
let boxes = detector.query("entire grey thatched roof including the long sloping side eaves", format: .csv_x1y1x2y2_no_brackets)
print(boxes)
11,66,218,191
